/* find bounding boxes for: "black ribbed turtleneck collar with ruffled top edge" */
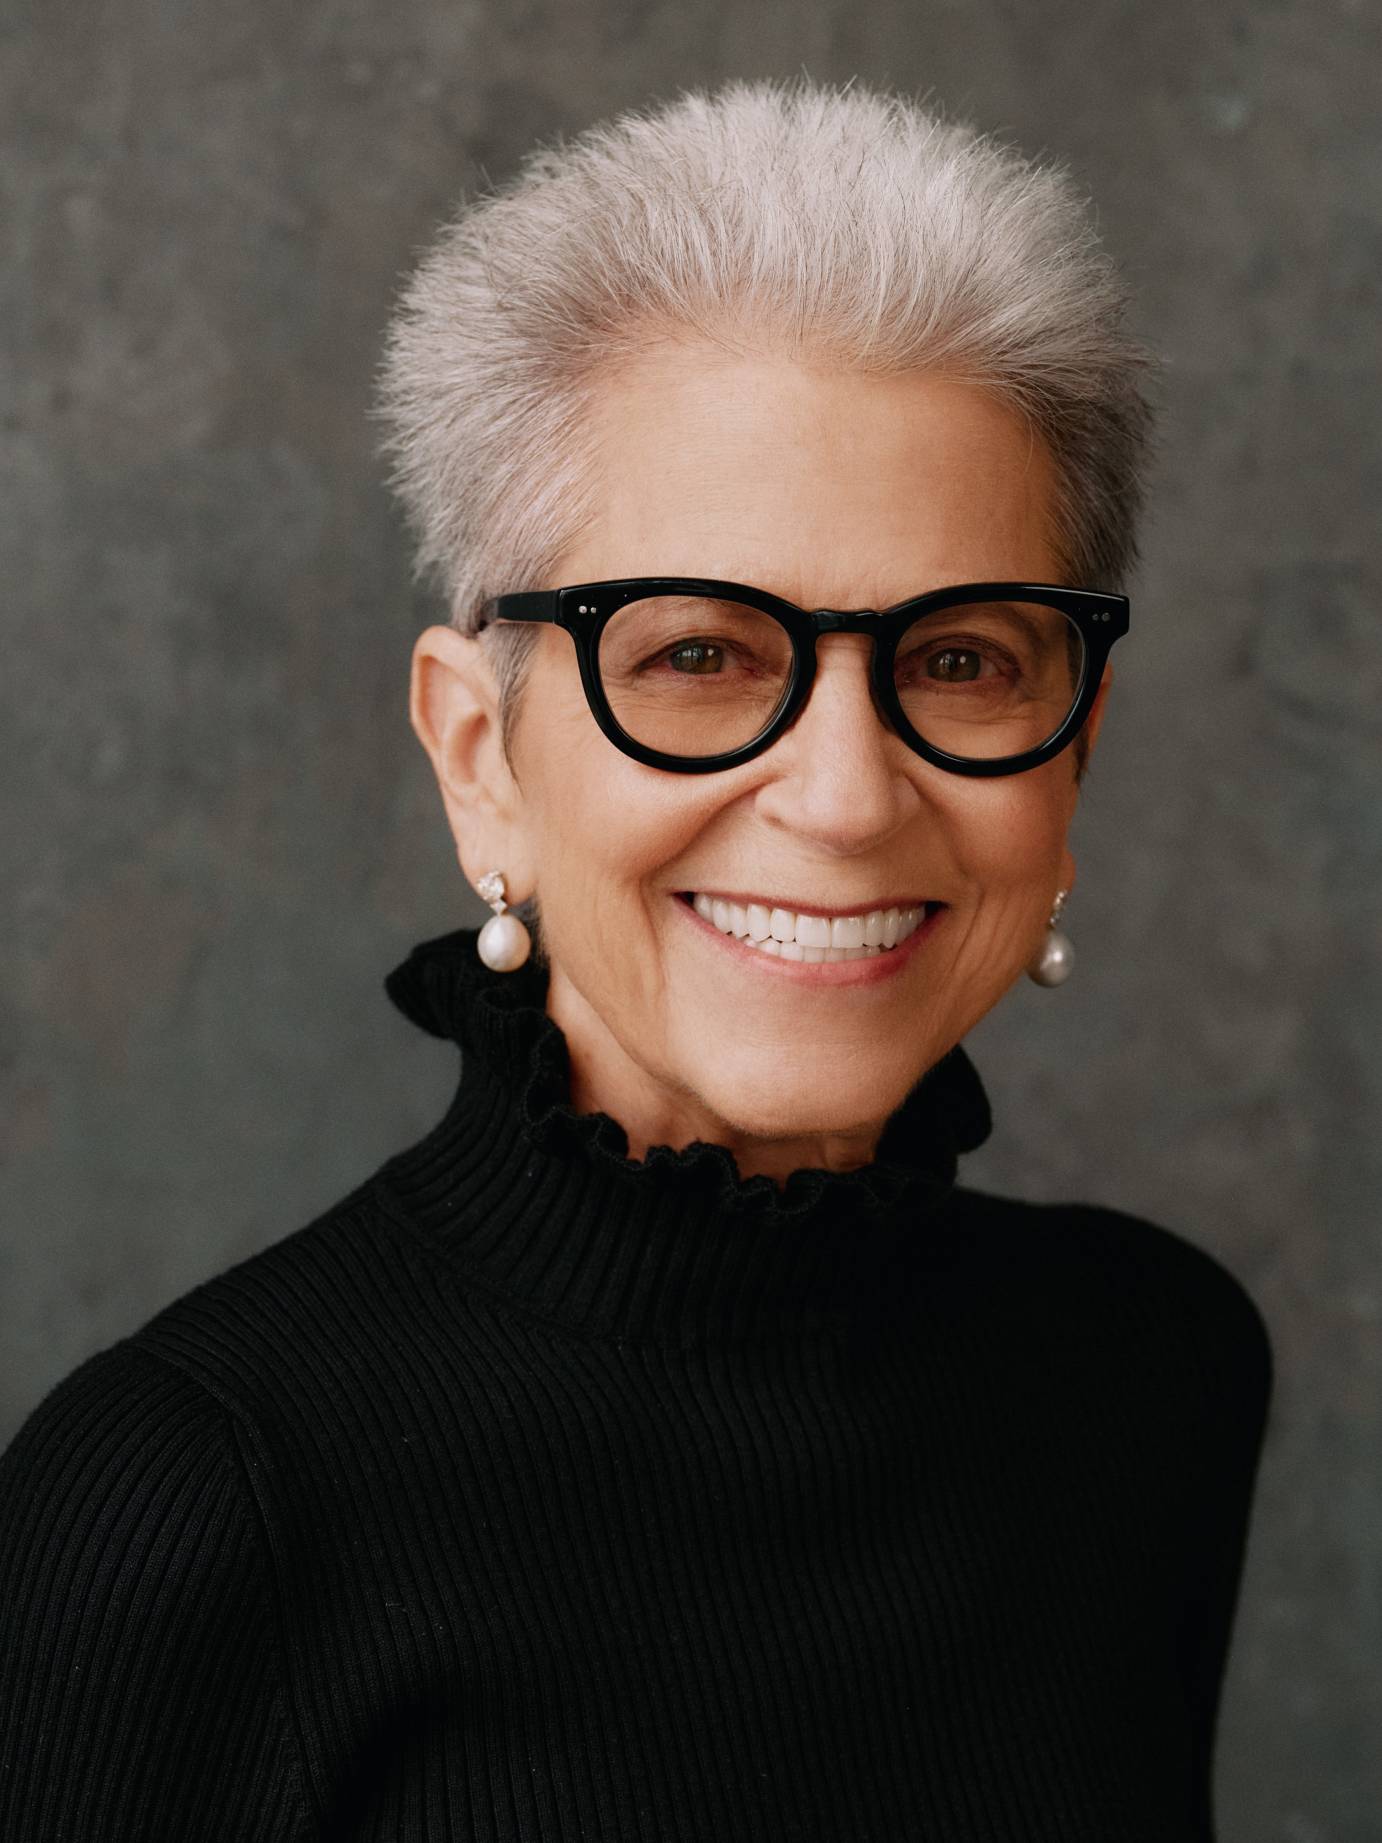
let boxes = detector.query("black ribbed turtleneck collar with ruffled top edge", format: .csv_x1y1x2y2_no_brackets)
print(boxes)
368,929,991,1344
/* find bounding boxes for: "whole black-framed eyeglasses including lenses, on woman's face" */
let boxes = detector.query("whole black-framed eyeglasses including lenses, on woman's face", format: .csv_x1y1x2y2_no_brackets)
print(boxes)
483,577,1128,774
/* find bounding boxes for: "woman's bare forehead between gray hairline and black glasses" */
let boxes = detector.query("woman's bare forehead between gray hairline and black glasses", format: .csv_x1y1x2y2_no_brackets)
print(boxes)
558,345,1058,606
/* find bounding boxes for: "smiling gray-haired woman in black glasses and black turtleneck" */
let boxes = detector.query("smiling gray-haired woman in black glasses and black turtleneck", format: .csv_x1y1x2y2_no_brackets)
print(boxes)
0,85,1271,1843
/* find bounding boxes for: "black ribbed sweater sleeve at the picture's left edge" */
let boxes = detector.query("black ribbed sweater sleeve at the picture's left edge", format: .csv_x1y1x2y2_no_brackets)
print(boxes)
0,1344,317,1843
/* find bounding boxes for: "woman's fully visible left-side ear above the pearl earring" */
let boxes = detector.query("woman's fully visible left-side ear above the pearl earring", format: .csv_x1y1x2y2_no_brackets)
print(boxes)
407,627,534,903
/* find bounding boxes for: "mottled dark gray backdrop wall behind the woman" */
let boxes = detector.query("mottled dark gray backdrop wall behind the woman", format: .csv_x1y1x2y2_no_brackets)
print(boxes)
0,0,1382,1843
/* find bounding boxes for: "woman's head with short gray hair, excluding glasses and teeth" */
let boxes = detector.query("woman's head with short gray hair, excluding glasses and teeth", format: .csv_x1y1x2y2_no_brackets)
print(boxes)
383,85,1148,1168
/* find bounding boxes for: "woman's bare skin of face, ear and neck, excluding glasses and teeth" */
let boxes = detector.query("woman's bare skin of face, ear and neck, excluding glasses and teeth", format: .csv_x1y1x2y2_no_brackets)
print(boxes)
411,345,1109,1180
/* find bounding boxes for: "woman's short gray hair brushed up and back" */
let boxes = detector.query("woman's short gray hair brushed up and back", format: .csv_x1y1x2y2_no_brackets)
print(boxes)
378,79,1150,774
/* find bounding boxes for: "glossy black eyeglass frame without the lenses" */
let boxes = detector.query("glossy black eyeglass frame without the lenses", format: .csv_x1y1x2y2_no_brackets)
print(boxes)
481,577,1130,778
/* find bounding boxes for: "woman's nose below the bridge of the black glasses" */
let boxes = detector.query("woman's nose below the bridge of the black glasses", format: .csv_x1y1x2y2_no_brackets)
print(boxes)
757,634,921,857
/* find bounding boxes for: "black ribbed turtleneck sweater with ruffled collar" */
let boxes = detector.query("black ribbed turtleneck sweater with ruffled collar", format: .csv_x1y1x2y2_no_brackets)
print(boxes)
0,931,1271,1843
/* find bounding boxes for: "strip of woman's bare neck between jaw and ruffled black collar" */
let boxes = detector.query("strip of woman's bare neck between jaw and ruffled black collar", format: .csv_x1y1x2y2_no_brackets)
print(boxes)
547,966,884,1183
